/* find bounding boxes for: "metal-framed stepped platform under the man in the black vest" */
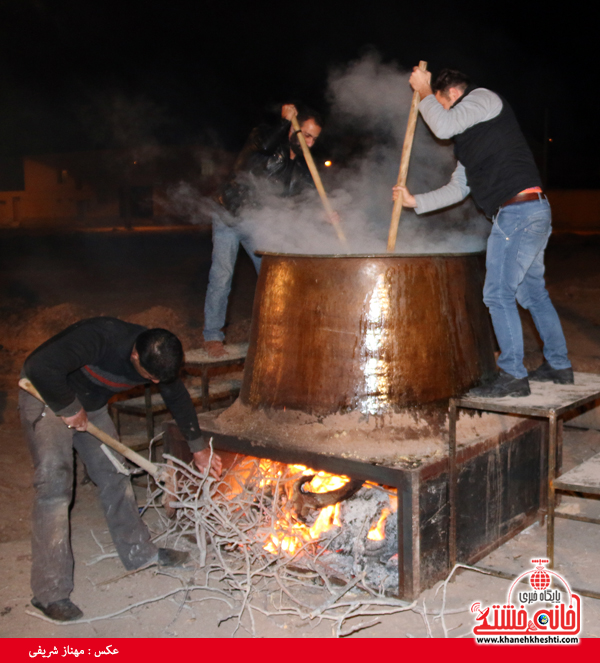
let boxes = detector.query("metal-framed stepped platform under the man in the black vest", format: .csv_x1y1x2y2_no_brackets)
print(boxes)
448,373,600,599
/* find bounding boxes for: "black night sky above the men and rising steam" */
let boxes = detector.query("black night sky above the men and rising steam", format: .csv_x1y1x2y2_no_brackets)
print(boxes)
0,0,600,188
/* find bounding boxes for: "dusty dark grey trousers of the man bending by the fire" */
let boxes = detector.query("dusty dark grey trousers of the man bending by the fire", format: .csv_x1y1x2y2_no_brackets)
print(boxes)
19,390,158,605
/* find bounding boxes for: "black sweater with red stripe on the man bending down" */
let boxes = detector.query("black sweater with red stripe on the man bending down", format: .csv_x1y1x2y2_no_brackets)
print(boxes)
23,318,207,452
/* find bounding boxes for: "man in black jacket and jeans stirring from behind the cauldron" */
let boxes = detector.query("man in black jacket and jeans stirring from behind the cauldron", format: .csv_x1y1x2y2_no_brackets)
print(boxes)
204,104,322,357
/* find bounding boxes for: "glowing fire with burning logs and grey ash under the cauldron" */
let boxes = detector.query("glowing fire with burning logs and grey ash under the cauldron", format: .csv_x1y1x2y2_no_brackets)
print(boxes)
219,457,398,588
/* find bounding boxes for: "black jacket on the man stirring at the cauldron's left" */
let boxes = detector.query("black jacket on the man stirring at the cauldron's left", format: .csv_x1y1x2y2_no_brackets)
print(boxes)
217,120,312,214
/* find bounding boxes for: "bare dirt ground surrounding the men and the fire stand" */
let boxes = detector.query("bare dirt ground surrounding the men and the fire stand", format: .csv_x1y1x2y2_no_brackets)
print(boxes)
0,228,600,638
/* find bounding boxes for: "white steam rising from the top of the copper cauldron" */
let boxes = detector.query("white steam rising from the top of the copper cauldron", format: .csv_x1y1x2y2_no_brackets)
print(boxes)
175,55,489,254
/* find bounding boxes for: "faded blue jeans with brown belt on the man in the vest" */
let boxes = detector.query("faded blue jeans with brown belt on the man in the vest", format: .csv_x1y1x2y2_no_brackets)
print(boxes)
483,198,571,378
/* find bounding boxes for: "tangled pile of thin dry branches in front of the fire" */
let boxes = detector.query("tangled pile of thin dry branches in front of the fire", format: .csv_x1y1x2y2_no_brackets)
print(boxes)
143,456,466,637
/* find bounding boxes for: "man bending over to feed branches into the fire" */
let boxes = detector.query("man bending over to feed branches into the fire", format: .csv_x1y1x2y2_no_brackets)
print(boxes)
19,318,221,621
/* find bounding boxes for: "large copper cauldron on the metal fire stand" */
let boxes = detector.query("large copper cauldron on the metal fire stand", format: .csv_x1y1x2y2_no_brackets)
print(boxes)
240,253,495,415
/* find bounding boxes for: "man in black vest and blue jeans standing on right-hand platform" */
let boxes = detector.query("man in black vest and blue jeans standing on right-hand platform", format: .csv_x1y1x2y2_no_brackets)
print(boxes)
394,67,573,398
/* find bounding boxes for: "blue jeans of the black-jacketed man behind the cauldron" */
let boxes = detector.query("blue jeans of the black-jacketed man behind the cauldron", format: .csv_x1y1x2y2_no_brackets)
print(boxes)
204,212,260,341
